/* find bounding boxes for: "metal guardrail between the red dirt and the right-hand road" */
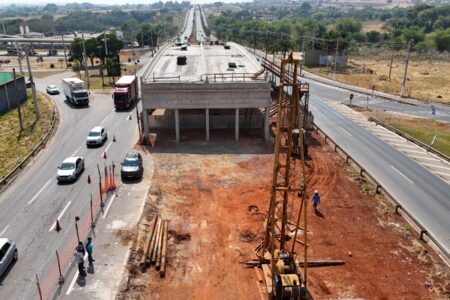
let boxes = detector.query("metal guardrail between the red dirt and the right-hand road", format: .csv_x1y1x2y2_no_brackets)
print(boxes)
314,124,450,258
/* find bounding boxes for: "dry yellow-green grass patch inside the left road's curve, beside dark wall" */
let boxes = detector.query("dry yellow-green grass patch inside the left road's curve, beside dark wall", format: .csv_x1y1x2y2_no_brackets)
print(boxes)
0,91,53,178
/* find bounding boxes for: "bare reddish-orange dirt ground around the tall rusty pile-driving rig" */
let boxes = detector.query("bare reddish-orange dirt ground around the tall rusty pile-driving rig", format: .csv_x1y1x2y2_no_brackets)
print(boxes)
118,133,450,299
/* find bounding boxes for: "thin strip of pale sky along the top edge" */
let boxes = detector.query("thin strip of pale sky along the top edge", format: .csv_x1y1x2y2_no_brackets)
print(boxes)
1,0,251,6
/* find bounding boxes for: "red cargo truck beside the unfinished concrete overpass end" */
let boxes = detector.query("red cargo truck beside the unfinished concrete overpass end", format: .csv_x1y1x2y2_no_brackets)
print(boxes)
112,75,138,109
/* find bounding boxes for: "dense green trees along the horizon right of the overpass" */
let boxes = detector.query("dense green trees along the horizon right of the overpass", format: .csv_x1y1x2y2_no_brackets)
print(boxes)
209,2,450,51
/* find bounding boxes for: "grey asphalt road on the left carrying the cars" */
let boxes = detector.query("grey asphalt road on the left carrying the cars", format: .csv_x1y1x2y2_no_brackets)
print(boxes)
0,74,142,299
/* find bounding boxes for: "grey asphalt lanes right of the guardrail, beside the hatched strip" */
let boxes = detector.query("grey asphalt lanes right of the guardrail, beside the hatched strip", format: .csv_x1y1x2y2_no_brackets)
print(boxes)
310,95,450,252
